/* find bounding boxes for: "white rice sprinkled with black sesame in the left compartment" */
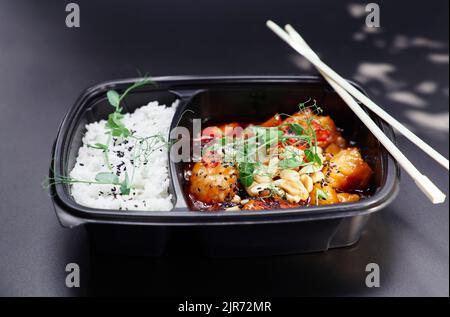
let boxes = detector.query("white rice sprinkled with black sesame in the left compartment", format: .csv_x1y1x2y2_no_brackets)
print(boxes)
70,101,177,211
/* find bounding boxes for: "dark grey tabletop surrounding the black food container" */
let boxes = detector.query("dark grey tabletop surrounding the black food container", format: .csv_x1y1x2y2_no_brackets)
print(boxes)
0,0,449,296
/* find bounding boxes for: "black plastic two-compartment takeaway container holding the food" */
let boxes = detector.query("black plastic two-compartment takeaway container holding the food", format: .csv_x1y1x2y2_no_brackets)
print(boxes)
50,76,399,256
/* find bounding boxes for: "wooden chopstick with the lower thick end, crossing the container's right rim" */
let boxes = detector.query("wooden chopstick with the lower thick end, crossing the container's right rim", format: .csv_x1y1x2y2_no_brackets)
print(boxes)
267,21,446,204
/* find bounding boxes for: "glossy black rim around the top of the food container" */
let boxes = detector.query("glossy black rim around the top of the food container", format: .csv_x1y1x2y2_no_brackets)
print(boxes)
50,75,399,227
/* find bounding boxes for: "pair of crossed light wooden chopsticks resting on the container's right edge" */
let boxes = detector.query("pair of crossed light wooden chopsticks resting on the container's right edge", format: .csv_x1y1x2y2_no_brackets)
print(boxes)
267,20,449,204
